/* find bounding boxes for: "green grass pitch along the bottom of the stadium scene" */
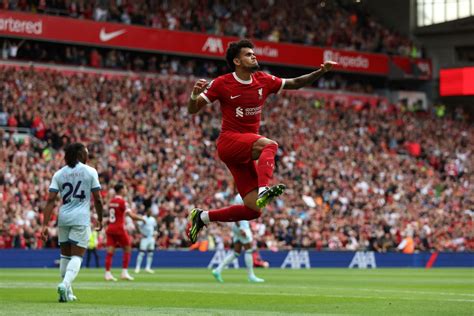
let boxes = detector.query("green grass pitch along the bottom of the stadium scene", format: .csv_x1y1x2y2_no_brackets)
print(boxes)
0,269,474,316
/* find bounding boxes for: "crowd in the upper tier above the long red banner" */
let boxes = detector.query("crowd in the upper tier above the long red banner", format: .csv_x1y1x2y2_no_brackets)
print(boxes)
2,0,422,57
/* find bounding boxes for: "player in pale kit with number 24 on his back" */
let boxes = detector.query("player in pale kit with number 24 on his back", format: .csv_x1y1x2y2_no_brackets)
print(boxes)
42,143,103,303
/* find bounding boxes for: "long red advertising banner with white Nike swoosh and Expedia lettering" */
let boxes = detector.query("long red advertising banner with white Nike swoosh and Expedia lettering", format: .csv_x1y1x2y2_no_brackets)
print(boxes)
0,10,430,76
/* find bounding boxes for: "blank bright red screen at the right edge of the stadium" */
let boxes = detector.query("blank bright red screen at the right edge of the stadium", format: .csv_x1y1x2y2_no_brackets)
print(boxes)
439,67,474,97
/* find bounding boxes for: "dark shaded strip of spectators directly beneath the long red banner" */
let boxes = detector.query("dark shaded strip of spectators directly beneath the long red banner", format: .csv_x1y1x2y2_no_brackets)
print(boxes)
0,39,380,93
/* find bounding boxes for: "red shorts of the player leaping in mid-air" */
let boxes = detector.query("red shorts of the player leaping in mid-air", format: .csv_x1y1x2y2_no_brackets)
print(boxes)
217,132,263,198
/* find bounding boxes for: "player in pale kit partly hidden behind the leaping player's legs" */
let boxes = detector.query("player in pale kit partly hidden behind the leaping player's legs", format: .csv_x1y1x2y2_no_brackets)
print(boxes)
212,195,265,283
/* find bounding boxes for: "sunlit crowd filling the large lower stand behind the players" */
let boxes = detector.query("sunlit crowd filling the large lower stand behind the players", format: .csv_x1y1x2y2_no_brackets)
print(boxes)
0,66,474,251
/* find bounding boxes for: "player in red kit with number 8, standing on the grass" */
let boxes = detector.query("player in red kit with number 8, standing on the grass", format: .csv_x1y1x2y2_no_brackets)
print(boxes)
105,182,143,281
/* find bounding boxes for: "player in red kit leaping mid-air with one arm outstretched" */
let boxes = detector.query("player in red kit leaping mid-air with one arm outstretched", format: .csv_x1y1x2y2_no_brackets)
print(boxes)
187,40,336,243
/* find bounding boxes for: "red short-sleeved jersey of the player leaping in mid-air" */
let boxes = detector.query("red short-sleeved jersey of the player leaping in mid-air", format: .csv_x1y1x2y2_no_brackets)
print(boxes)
201,71,285,134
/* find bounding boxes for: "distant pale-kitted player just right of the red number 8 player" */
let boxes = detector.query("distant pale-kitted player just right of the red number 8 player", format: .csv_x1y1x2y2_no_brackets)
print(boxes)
135,208,157,274
